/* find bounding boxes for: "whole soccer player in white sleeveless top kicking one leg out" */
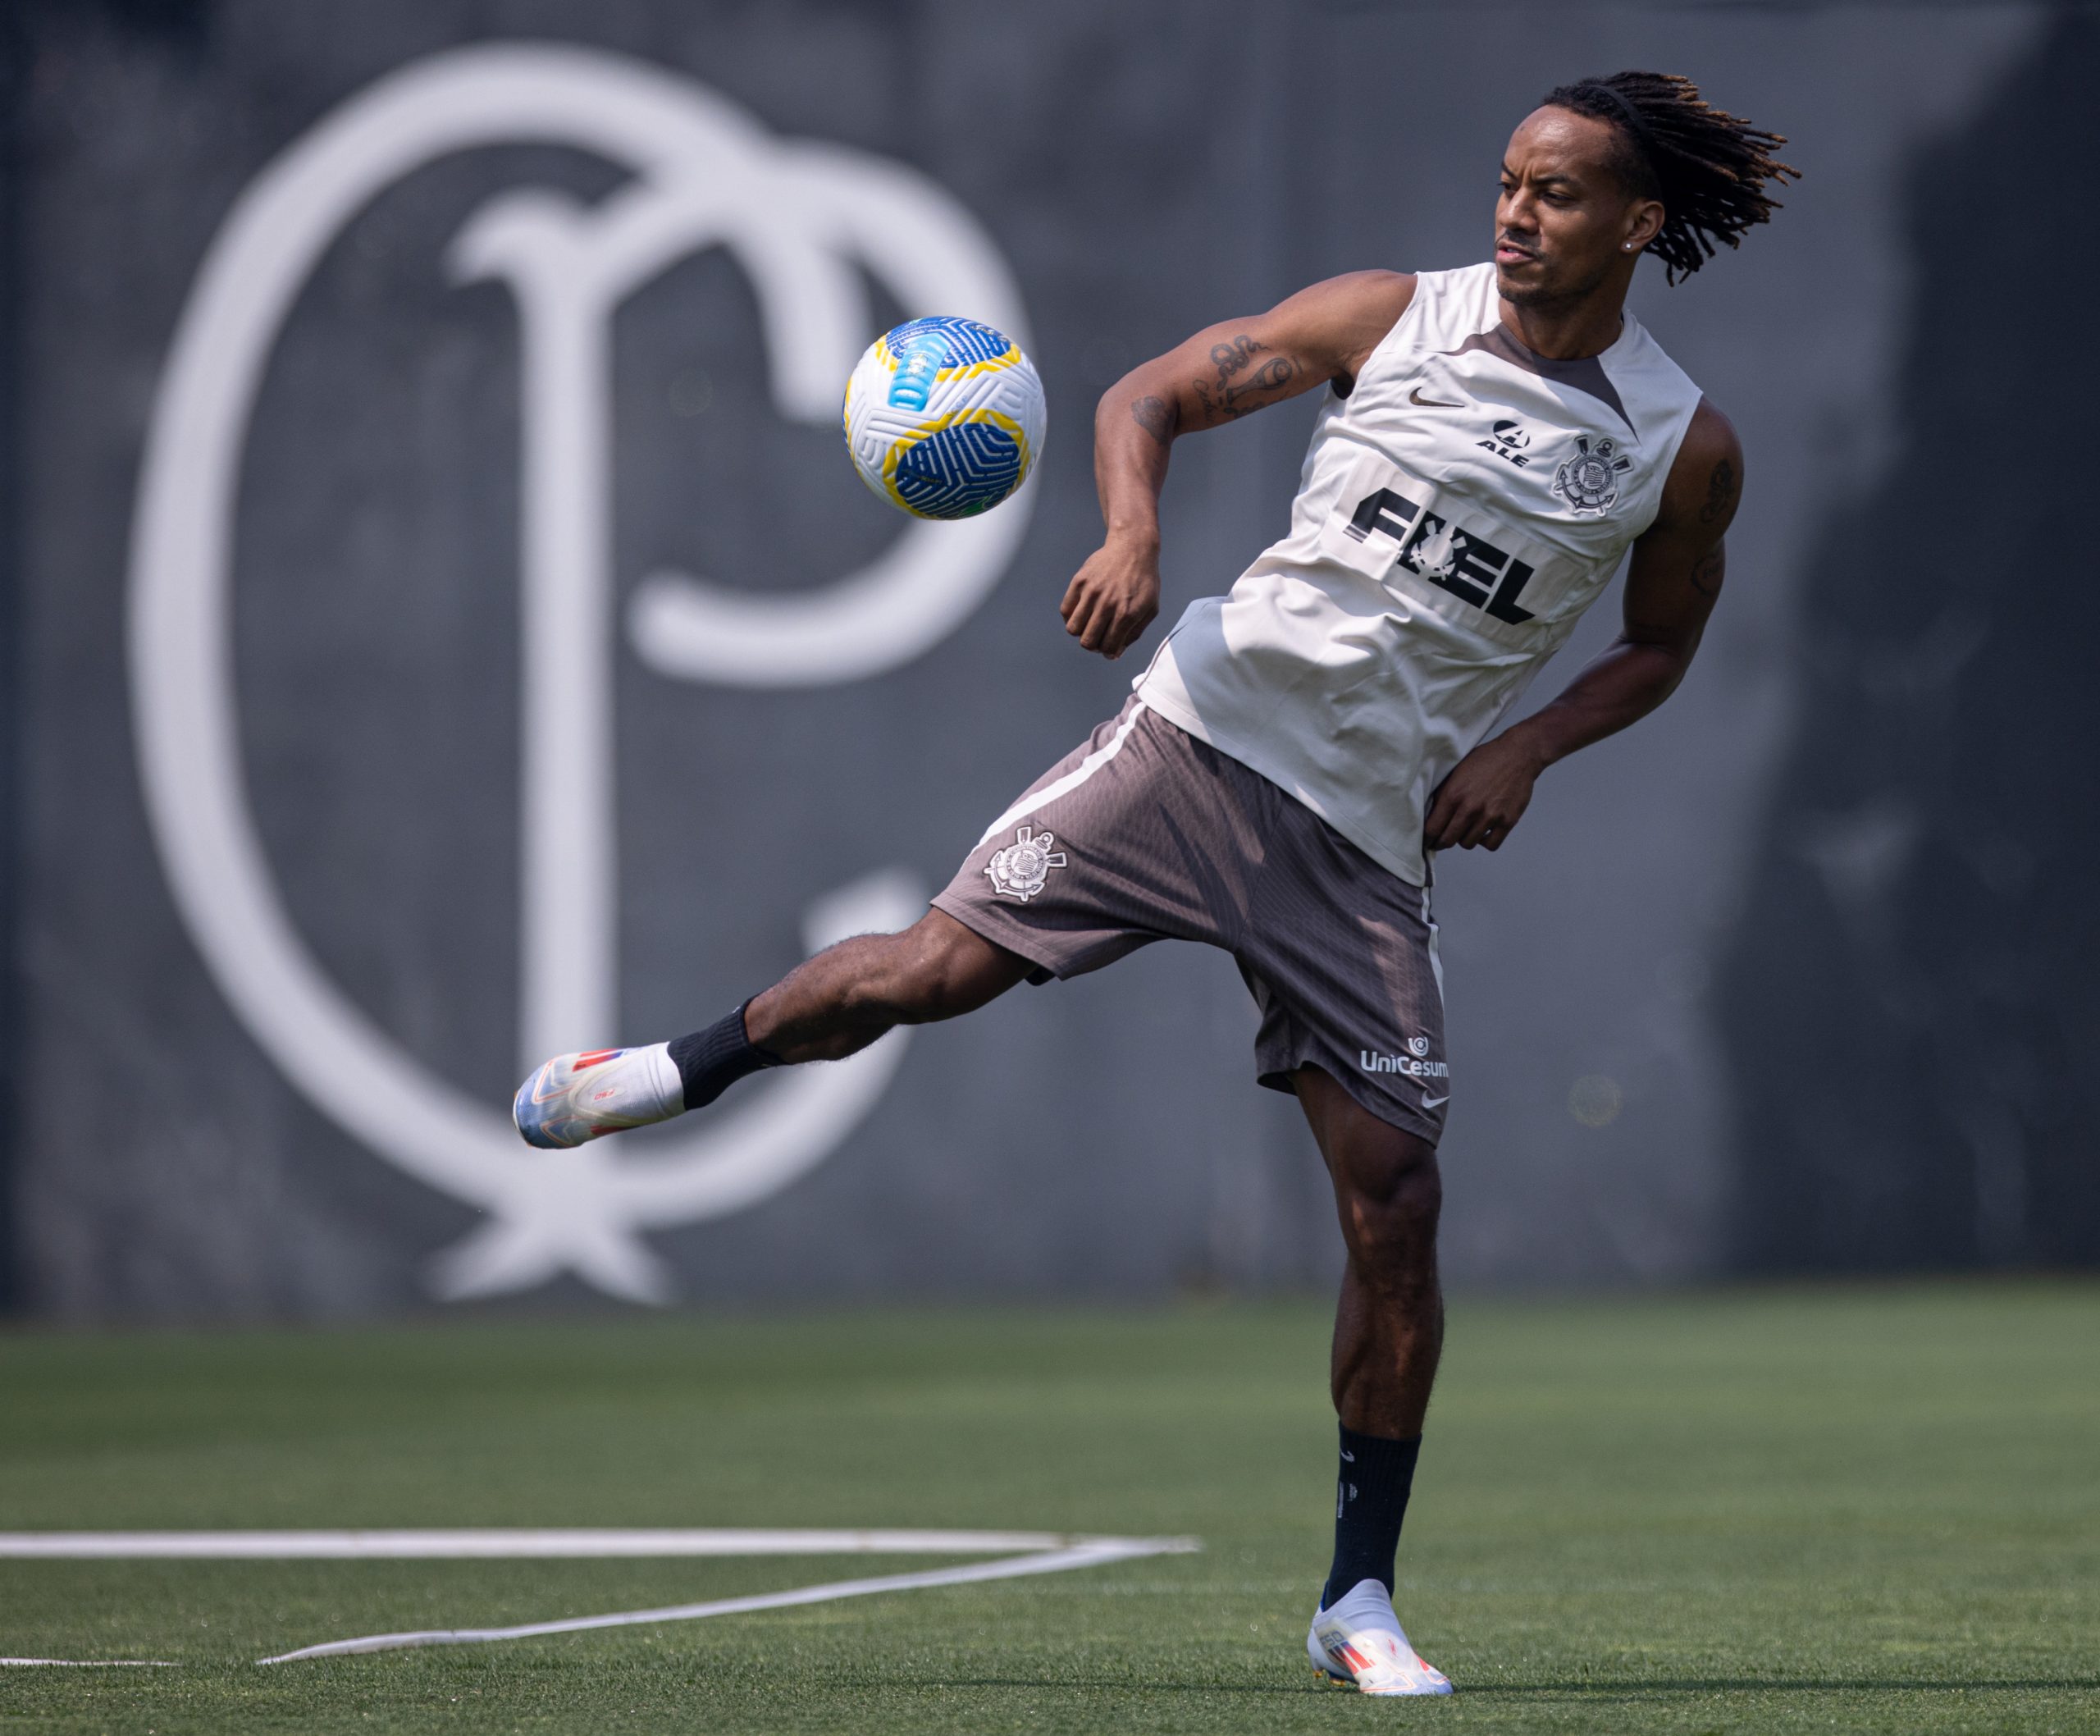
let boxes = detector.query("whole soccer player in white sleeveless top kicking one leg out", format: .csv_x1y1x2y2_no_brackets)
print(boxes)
517,71,1793,1694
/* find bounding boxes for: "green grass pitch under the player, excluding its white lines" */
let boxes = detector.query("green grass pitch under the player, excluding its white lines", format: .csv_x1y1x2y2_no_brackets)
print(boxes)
0,1285,2100,1736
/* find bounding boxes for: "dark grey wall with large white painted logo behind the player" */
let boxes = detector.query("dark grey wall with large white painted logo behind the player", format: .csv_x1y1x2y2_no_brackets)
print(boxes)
0,0,2100,1318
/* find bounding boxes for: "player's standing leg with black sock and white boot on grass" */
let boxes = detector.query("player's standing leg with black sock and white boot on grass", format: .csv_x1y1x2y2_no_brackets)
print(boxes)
1294,1067,1451,1694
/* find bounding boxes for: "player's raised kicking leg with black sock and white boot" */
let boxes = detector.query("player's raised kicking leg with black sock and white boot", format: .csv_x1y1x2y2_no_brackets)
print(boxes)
510,911,1029,1149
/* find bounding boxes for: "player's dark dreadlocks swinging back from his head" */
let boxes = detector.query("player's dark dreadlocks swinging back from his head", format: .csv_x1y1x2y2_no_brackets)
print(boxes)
1545,71,1801,283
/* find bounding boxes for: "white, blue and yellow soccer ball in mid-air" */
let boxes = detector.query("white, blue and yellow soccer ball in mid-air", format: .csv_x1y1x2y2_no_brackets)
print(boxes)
844,315,1046,519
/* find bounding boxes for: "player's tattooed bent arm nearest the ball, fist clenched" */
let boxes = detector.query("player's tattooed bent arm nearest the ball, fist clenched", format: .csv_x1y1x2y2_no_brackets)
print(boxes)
1061,271,1415,659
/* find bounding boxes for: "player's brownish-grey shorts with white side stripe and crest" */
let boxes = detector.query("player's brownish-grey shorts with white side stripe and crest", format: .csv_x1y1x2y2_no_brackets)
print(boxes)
933,697,1451,1144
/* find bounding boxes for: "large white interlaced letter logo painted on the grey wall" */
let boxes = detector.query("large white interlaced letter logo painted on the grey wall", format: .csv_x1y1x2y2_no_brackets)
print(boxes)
130,46,1031,1300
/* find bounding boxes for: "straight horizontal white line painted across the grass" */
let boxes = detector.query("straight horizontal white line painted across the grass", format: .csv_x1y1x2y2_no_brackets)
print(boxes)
0,1528,1121,1562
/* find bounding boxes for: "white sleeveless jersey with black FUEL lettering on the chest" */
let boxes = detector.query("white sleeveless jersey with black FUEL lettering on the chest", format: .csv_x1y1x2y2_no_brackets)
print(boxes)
1134,264,1699,886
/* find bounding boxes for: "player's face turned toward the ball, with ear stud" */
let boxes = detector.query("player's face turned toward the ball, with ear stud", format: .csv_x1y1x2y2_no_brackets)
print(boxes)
1495,109,1664,307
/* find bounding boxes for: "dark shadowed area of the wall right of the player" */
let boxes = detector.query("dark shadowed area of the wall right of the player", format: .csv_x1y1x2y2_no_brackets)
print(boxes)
1720,16,2100,1270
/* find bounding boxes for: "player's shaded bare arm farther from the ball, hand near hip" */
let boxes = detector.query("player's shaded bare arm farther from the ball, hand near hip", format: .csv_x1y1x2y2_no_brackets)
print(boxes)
1424,403,1743,850
